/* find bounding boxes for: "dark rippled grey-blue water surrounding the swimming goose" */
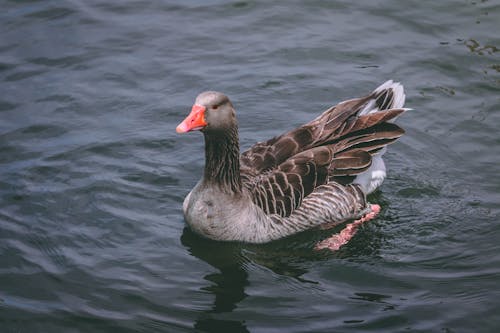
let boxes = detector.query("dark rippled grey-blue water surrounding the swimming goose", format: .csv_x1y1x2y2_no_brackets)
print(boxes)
0,0,500,332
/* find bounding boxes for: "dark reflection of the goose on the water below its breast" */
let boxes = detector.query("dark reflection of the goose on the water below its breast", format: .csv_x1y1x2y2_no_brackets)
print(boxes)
181,228,318,332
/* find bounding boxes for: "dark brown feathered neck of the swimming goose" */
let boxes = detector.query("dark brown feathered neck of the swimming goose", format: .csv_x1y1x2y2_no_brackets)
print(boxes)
204,126,242,194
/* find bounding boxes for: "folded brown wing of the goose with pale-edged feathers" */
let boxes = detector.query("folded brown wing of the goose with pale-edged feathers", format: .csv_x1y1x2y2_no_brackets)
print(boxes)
240,86,405,217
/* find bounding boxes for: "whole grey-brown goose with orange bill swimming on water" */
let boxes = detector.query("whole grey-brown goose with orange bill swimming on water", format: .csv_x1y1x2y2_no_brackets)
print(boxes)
176,80,409,251
